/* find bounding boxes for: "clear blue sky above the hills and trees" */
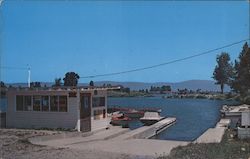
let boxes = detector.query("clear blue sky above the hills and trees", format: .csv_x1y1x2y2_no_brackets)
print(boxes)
1,1,249,82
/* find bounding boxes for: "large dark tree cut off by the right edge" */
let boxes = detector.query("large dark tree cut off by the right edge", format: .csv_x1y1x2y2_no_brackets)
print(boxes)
231,43,250,95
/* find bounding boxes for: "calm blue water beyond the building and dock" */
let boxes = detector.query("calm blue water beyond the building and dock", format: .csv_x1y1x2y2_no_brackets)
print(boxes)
108,97,236,141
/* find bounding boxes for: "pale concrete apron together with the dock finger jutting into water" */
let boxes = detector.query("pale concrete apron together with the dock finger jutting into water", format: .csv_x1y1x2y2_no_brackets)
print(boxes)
29,118,189,158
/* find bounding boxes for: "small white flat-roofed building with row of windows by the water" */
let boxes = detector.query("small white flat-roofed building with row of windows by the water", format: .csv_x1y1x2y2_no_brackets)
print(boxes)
6,88,116,132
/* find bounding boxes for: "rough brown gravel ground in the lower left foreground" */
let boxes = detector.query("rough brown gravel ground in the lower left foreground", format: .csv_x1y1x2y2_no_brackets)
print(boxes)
0,129,139,159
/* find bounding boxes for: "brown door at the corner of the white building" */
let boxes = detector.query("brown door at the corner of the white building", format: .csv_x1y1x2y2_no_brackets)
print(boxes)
80,93,91,132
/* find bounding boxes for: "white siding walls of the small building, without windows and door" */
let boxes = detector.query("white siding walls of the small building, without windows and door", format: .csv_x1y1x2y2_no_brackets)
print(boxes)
6,89,109,131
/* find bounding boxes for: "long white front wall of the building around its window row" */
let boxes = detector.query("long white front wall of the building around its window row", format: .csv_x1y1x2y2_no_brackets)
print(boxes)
6,91,79,129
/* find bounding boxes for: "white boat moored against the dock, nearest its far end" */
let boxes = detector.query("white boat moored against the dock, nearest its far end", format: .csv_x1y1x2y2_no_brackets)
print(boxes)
140,112,165,125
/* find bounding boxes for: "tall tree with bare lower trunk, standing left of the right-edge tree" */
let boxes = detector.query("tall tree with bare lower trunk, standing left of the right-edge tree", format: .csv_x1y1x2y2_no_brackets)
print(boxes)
213,52,233,94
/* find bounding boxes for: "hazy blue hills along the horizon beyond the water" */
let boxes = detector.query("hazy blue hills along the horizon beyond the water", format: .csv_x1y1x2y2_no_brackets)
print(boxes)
7,80,230,92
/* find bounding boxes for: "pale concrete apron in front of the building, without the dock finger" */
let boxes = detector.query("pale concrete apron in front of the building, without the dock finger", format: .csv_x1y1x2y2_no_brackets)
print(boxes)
30,124,188,158
